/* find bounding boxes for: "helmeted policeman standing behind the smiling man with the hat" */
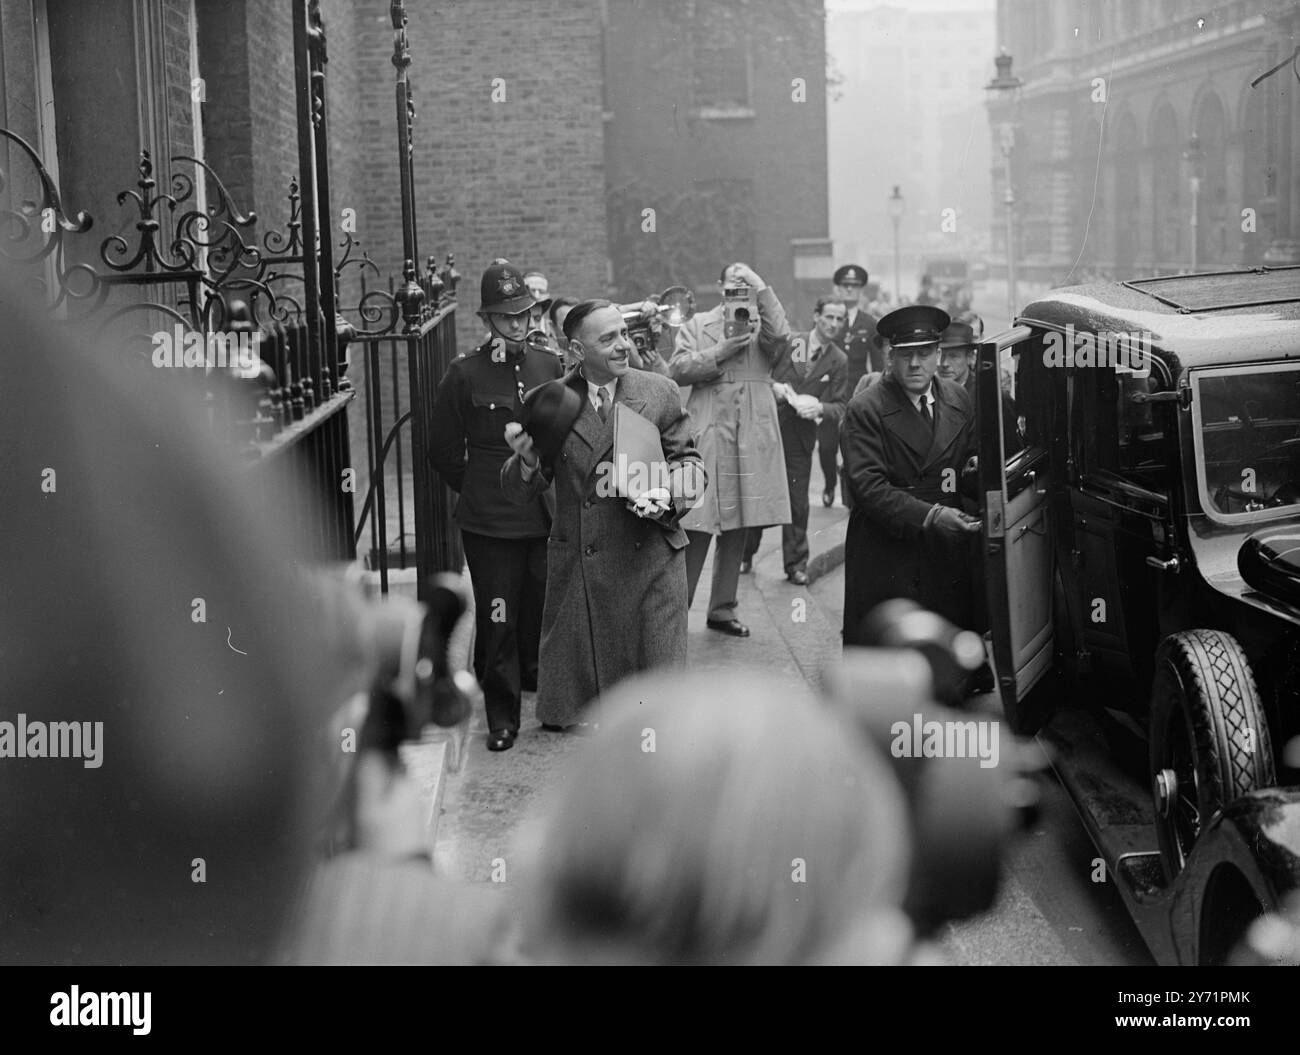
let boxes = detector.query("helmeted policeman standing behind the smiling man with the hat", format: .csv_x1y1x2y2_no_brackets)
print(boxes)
429,261,563,751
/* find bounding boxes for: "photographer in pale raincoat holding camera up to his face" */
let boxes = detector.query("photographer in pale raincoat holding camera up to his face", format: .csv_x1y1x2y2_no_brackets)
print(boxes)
668,264,790,638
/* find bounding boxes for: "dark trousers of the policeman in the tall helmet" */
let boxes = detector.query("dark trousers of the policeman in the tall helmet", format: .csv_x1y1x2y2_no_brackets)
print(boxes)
460,530,546,733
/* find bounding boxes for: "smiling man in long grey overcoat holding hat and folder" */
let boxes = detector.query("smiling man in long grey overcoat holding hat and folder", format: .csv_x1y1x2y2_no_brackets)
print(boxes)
501,300,707,731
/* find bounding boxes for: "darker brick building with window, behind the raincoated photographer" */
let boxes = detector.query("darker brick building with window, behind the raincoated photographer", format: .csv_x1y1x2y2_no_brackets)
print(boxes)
602,0,833,325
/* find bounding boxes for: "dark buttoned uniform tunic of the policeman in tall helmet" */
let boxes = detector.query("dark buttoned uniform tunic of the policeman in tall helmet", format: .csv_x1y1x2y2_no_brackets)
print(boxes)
429,342,563,538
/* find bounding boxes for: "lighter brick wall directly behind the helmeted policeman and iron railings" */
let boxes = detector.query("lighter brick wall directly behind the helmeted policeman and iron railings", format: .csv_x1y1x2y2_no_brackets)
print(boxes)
356,0,606,350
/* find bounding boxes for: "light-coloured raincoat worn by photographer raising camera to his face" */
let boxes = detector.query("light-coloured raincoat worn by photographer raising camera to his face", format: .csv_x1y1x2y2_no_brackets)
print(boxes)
668,287,790,535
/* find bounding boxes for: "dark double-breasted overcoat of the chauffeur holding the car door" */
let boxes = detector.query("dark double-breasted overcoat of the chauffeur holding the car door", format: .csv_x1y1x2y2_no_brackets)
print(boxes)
840,374,979,644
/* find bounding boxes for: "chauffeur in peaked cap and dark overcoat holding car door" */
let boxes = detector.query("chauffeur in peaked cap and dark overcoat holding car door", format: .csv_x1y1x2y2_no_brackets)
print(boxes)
840,305,979,646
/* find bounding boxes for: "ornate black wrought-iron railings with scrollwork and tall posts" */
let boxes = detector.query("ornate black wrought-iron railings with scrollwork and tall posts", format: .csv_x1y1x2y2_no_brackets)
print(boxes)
0,0,462,598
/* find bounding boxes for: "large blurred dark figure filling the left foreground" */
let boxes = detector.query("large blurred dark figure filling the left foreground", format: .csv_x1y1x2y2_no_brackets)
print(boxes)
0,267,365,963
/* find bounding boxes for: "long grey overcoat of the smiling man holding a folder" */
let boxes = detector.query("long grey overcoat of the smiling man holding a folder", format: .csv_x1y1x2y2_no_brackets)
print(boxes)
501,370,707,725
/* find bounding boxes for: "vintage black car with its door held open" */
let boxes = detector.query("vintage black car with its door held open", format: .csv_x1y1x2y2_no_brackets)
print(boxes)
978,268,1300,964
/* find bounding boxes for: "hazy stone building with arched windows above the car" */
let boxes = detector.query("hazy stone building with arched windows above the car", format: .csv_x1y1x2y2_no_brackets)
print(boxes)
989,0,1300,285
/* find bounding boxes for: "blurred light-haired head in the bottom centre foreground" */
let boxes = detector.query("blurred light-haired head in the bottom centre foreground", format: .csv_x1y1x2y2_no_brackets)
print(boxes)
520,672,911,964
